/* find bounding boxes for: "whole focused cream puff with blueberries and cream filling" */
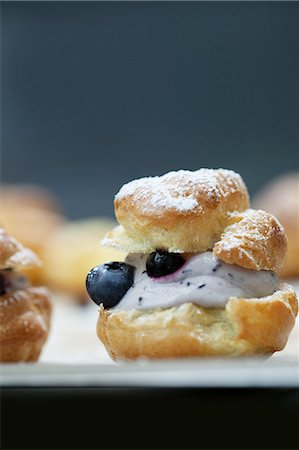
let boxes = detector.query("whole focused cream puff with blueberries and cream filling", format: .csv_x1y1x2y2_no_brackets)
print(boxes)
86,169,298,359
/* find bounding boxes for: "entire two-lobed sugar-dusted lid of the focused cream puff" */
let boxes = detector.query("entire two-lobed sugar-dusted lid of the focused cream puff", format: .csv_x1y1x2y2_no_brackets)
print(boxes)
102,169,287,271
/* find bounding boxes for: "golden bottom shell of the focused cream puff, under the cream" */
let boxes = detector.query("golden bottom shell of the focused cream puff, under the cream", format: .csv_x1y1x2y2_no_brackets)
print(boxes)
97,284,298,360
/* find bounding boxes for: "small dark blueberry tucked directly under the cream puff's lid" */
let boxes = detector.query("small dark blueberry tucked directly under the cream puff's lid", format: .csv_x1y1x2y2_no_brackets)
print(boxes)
146,250,185,278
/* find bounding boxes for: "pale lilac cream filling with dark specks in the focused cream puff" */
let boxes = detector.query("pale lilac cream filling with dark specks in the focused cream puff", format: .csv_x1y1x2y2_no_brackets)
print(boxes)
113,252,280,310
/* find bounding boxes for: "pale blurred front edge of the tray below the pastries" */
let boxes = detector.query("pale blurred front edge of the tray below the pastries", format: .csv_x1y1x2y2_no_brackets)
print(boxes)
1,357,299,388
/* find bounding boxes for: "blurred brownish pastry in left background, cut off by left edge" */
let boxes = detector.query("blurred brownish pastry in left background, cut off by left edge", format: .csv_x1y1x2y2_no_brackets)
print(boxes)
0,184,65,284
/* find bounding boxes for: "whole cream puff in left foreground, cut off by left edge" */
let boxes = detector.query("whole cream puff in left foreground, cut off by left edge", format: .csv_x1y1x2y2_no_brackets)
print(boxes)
0,228,51,362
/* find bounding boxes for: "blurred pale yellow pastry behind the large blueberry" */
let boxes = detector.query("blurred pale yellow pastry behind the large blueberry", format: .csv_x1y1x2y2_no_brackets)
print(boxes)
42,218,126,303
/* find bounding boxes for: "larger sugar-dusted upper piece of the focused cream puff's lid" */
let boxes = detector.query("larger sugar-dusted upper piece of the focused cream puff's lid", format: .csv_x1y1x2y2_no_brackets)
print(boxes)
108,169,249,253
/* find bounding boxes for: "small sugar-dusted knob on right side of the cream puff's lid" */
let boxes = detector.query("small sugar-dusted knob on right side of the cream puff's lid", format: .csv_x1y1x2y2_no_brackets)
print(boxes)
213,209,287,272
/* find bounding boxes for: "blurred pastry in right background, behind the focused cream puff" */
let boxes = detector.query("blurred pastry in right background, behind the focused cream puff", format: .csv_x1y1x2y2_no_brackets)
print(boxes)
253,172,299,278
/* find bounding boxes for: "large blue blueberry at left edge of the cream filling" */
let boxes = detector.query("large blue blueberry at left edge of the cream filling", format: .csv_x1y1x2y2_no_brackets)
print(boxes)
86,262,135,308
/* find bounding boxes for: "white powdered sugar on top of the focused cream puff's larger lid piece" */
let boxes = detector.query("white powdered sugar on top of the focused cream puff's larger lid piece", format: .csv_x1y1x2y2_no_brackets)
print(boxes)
115,169,241,212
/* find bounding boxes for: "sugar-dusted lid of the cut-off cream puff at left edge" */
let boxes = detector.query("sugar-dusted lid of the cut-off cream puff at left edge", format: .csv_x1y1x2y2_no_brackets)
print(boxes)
0,228,41,270
